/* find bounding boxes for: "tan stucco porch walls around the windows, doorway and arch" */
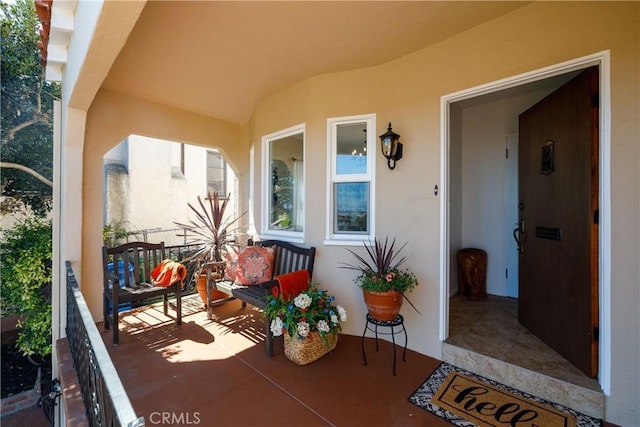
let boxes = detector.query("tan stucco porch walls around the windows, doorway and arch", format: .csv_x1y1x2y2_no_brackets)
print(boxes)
53,2,640,425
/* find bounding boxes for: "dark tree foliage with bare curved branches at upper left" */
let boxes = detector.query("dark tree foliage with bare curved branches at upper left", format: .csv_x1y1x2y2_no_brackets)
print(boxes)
0,0,60,215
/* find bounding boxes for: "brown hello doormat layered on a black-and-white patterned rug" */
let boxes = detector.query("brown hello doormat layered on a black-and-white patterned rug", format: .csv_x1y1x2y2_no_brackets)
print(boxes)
409,362,602,427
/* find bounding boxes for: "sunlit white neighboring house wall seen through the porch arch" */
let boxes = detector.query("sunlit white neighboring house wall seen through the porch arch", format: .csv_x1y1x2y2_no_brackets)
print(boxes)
104,135,237,245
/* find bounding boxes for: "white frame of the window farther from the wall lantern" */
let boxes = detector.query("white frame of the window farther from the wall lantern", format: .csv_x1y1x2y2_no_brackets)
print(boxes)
260,123,307,243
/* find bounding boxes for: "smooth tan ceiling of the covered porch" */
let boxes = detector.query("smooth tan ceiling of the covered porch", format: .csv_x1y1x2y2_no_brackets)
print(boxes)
43,0,528,123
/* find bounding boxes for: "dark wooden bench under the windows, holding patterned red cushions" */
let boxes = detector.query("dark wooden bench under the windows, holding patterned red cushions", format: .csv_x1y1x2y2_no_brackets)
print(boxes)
205,240,316,357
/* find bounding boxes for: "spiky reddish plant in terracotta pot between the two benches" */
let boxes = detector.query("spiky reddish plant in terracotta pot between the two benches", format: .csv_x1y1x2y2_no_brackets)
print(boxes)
175,191,244,306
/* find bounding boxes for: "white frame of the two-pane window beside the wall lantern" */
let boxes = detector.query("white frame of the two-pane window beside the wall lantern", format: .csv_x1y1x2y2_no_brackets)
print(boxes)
324,114,377,246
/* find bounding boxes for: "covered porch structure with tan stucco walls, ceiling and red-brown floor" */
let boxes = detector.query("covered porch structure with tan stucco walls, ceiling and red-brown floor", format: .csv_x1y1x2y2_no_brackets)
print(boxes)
38,0,640,425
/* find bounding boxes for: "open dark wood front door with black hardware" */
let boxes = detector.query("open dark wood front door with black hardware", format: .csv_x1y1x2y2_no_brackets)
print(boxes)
516,67,599,377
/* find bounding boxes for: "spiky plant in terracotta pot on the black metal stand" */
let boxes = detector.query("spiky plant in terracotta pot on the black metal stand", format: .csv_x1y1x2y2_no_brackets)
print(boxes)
342,238,419,320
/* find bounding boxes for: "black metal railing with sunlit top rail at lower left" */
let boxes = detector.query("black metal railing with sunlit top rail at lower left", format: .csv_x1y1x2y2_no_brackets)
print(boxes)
66,261,145,427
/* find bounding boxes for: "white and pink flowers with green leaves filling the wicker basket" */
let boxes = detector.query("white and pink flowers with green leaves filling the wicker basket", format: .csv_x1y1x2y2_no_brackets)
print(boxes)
264,285,347,341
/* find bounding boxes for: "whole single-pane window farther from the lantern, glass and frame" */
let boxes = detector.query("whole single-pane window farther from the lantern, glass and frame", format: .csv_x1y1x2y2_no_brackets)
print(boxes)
262,124,305,241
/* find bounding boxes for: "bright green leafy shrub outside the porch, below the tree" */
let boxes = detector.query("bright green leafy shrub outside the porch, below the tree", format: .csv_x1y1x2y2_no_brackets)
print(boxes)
0,217,52,356
